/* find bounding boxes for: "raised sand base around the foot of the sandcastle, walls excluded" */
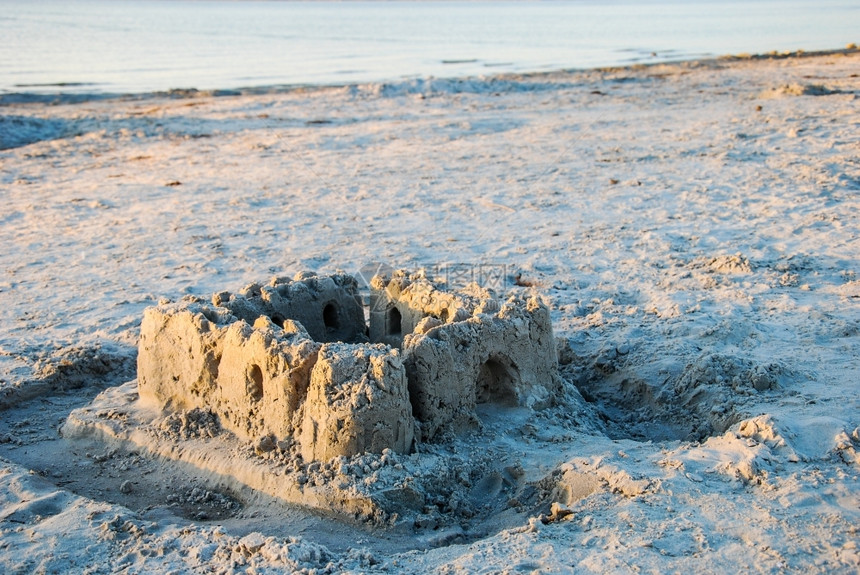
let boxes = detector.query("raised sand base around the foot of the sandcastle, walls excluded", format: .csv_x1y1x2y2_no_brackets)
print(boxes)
61,381,596,536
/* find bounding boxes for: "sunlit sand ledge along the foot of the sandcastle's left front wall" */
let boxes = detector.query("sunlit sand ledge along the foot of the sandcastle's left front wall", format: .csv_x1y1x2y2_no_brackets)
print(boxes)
62,381,409,520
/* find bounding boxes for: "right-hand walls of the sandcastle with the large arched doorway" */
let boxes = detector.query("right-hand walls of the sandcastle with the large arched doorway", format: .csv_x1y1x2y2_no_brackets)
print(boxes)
370,271,559,440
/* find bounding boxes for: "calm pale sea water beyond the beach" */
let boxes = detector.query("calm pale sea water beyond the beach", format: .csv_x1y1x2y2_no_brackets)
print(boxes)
0,0,860,94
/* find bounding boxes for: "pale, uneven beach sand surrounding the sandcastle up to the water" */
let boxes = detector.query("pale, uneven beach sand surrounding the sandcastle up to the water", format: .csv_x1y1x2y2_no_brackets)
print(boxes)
0,50,860,573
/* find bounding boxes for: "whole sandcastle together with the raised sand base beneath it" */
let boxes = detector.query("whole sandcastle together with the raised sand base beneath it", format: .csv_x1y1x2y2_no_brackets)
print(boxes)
63,271,578,546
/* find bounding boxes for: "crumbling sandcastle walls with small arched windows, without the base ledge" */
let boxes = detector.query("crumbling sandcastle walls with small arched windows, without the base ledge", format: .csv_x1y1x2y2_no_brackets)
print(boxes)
138,271,560,461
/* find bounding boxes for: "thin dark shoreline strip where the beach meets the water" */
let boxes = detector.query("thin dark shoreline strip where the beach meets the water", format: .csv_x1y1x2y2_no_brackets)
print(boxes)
0,43,860,106
